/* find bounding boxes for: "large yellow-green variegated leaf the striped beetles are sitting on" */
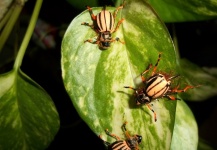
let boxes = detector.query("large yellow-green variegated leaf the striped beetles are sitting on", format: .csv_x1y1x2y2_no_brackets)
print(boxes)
61,0,198,149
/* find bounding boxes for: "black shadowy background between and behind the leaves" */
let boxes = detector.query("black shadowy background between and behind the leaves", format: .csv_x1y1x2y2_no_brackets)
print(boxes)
0,0,217,150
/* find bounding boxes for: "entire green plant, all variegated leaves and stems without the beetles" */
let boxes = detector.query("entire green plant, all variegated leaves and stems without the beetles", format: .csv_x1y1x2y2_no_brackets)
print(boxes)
0,0,217,150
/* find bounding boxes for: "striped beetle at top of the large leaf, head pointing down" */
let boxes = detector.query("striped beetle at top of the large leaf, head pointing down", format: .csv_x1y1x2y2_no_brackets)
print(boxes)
81,3,124,50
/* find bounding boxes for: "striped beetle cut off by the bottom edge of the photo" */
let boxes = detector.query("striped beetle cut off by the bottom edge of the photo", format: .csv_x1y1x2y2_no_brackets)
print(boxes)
99,122,142,150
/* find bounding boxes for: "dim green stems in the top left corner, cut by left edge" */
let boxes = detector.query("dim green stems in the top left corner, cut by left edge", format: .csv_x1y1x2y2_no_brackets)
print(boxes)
0,0,25,53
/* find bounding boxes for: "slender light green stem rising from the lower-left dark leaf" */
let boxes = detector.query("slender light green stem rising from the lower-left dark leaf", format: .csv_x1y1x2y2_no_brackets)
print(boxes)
14,0,43,71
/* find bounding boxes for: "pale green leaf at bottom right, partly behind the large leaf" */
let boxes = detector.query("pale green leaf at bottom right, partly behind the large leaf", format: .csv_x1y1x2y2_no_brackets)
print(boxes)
171,101,198,150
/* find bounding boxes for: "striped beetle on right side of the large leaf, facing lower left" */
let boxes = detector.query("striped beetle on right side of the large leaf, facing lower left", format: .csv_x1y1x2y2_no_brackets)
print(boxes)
124,53,197,122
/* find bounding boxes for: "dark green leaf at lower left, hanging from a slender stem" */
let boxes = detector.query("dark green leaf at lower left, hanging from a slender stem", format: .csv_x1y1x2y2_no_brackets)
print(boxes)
0,70,59,150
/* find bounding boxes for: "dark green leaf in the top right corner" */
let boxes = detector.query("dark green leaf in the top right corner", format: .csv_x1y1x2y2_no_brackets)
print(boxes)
148,0,217,22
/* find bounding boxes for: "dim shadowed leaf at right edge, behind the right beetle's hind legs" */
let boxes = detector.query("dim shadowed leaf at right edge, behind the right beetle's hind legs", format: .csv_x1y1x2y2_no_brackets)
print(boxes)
180,59,217,101
